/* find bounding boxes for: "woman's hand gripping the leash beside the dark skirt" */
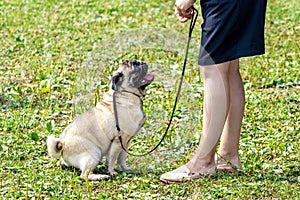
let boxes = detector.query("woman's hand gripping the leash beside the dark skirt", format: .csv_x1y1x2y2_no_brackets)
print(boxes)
175,0,196,23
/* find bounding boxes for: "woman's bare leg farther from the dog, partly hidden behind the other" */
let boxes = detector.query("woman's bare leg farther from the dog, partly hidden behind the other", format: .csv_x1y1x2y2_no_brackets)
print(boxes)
217,59,245,170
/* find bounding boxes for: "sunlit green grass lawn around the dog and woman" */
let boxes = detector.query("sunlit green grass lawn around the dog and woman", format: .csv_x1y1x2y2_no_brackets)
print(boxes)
0,0,300,199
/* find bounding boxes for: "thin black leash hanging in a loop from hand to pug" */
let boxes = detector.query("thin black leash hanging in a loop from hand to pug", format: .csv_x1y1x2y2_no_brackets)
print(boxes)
113,7,198,156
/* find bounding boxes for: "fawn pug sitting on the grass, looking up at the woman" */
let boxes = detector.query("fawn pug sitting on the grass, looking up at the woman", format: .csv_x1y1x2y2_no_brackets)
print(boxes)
47,60,154,181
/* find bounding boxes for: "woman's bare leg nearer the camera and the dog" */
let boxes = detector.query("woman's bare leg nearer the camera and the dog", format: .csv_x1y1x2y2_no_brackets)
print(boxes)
186,62,230,174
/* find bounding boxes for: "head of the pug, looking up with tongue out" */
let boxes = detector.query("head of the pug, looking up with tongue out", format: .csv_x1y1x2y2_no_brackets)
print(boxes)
111,60,154,95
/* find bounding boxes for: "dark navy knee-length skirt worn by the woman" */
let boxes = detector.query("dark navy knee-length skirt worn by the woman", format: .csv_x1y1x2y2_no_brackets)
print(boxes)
198,0,267,65
